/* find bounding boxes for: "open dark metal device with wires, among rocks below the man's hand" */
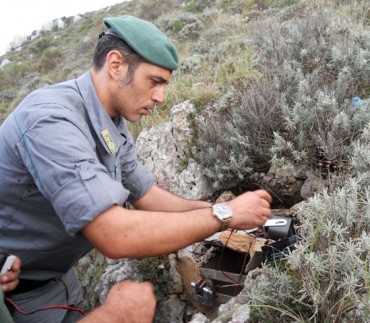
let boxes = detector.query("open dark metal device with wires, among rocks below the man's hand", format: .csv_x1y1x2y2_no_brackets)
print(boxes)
191,217,297,307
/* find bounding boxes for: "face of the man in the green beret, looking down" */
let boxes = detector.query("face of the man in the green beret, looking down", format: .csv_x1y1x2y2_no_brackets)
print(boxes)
113,63,171,121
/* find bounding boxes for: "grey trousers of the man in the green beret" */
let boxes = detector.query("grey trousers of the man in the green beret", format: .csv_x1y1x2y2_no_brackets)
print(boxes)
11,269,83,323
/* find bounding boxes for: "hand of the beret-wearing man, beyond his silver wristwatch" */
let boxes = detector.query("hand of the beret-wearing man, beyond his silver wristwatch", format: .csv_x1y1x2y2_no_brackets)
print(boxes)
226,190,272,230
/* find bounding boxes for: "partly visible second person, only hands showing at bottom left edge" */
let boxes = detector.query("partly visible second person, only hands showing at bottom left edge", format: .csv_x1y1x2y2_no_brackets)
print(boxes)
0,257,156,323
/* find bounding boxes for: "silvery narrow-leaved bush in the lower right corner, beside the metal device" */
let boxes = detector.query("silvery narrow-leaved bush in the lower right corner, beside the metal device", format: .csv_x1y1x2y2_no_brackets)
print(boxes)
244,179,370,322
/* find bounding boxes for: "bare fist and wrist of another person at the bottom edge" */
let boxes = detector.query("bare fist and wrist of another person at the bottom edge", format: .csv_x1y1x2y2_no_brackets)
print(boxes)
78,281,156,323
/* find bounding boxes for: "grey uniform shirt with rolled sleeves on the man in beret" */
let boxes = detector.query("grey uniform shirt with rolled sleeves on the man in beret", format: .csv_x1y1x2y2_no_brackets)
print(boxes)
0,72,153,280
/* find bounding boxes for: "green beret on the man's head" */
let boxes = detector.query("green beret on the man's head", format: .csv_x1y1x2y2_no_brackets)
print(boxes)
103,15,179,70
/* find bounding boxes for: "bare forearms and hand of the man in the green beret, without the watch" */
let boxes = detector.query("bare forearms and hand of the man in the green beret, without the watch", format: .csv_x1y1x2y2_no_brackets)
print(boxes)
82,190,272,259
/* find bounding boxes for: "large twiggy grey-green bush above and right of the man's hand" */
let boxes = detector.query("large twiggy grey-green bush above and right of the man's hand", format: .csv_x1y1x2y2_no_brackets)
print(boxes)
195,3,370,191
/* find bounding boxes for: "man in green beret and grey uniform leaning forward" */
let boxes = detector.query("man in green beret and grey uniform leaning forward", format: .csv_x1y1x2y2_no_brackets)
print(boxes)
0,16,271,322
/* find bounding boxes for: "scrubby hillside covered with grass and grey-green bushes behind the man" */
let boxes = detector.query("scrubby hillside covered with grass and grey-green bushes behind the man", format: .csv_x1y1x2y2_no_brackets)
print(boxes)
0,0,370,322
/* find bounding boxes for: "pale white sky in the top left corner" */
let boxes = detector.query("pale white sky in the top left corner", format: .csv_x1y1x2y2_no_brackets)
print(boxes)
0,0,125,55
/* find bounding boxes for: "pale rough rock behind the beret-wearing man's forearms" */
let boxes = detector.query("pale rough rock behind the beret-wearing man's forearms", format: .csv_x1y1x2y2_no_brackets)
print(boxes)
136,101,211,199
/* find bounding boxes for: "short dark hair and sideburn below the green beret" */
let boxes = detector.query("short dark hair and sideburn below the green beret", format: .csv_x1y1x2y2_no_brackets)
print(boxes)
93,33,146,84
